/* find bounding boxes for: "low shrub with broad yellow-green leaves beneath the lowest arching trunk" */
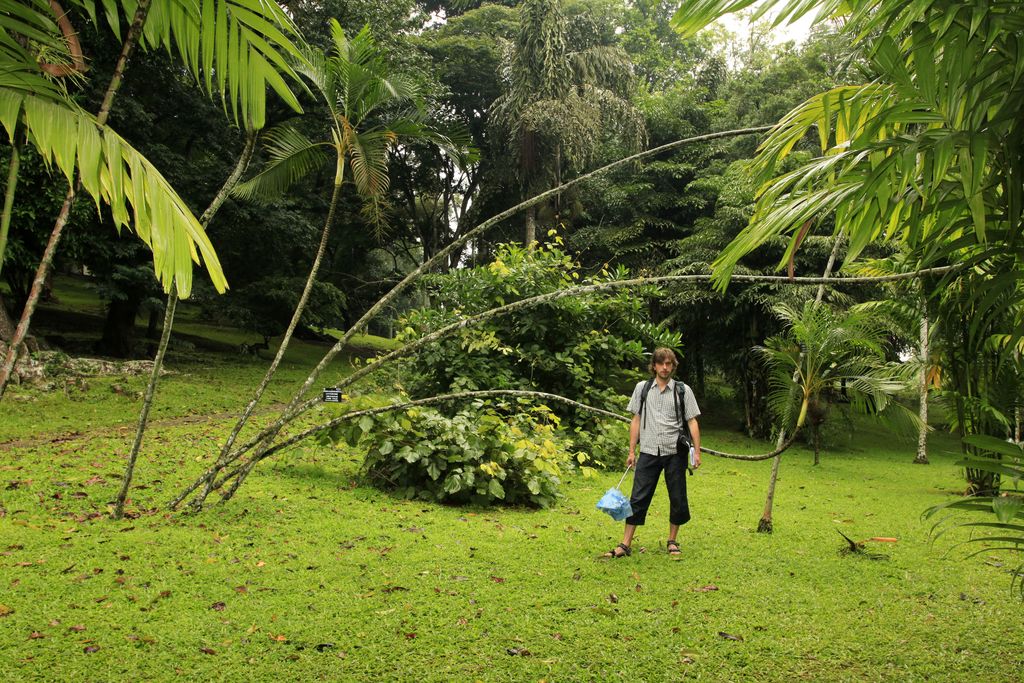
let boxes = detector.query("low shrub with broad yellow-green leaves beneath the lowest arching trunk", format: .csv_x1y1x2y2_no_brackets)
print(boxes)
332,402,589,507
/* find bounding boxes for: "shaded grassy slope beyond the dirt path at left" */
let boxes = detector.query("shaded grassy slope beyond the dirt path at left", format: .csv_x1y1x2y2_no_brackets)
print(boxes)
0,275,394,441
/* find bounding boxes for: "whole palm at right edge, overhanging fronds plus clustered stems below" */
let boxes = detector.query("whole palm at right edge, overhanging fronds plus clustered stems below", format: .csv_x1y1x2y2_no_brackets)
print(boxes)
674,0,1024,488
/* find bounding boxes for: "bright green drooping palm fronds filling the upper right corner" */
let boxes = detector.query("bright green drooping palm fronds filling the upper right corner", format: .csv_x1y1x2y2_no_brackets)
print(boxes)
674,0,1024,284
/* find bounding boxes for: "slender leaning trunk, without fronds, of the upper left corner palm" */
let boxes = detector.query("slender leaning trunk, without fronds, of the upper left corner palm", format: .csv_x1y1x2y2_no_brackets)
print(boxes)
0,0,151,399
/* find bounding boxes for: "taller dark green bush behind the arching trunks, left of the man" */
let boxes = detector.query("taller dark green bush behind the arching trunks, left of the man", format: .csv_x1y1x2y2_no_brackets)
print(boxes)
400,236,680,454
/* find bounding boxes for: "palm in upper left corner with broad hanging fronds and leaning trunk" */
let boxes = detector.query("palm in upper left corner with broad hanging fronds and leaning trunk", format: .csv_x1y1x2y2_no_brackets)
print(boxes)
0,0,301,397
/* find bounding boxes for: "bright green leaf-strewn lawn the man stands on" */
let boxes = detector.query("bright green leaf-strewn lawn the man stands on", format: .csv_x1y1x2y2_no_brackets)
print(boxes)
0,376,1024,683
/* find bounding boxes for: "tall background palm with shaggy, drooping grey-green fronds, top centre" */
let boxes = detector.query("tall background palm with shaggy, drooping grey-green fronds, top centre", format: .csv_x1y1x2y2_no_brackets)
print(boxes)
490,0,645,246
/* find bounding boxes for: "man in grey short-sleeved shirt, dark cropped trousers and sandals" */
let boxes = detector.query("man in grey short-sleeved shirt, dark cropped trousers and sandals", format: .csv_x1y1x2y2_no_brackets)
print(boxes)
604,348,700,558
